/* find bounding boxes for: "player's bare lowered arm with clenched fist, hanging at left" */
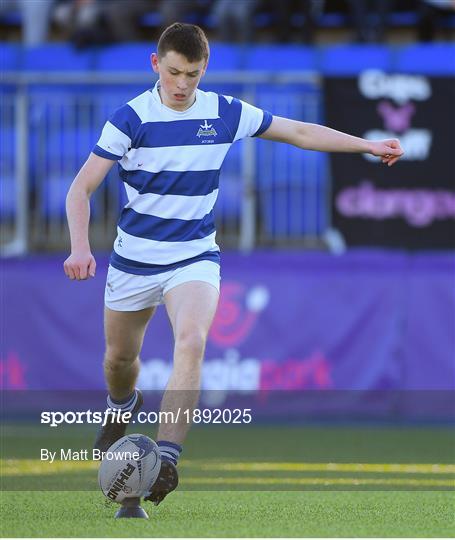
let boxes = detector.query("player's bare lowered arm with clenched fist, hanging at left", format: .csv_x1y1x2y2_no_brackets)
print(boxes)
63,153,114,280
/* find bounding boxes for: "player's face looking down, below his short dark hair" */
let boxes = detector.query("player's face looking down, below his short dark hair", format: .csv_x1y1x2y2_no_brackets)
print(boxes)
151,51,207,111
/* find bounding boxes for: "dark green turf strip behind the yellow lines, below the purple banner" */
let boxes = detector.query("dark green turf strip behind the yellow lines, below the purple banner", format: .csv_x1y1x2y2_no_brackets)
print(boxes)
0,422,455,463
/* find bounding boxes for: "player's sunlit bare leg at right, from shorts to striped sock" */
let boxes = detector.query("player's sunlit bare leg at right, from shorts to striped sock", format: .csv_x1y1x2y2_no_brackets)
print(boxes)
158,281,219,444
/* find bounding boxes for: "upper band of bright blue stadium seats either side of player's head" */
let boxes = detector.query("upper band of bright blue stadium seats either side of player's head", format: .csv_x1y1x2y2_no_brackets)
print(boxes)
0,42,455,75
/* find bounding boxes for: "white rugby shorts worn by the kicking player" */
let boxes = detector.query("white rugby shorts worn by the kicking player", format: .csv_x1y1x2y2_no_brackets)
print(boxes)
104,261,220,311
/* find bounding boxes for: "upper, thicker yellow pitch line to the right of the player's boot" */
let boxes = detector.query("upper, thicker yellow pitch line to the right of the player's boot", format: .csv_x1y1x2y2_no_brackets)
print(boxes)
181,461,455,474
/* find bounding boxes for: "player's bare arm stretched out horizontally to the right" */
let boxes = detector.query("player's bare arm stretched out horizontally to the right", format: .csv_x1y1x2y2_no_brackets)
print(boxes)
260,116,404,166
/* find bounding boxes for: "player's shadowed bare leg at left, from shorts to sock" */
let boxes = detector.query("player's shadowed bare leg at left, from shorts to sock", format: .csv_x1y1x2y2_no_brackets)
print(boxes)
104,308,156,401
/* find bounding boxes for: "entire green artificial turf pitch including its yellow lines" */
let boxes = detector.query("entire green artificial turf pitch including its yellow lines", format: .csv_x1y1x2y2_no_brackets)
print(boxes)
0,425,455,538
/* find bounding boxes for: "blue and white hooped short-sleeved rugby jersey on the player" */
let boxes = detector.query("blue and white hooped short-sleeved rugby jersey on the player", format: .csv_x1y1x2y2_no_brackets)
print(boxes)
93,83,272,275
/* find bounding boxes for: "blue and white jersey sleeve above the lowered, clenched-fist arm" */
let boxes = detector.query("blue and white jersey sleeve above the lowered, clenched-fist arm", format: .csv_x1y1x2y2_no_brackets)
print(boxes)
92,105,141,161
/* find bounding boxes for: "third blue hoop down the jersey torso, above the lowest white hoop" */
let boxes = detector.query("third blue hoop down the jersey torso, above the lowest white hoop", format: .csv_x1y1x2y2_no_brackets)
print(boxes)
118,208,215,242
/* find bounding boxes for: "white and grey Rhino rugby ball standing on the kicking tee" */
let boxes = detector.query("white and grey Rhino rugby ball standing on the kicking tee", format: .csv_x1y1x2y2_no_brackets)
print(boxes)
98,433,161,503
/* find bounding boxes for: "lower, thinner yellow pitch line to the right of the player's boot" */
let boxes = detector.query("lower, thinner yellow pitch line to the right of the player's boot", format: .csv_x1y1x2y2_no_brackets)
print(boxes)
181,477,455,489
